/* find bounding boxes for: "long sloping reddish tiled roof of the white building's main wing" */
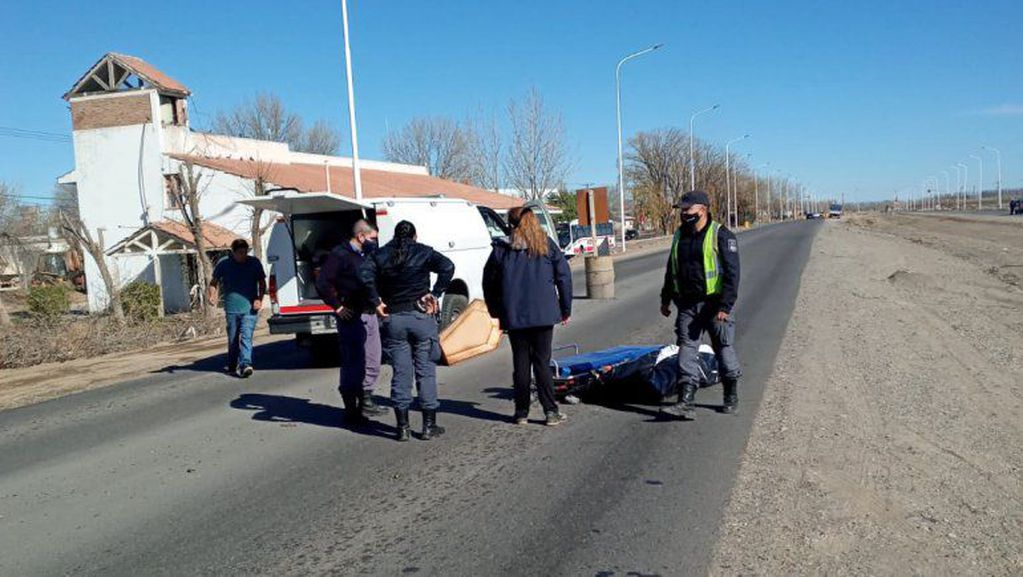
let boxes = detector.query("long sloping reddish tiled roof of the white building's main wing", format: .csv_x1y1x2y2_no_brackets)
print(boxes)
172,154,523,210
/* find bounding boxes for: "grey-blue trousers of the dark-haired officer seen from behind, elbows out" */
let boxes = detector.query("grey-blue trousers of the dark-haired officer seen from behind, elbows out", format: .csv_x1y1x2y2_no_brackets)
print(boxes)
381,312,440,410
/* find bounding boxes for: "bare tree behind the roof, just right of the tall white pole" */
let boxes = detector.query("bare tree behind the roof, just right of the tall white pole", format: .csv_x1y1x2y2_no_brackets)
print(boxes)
383,117,474,182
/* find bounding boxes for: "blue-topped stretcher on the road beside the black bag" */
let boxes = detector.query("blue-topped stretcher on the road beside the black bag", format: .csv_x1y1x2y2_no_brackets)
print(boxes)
550,345,663,397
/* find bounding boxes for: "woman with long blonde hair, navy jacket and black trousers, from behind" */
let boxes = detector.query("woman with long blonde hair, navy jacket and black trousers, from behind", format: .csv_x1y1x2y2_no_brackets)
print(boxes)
483,208,572,426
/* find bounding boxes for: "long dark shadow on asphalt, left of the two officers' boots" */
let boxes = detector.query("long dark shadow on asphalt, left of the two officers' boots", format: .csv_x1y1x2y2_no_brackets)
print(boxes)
230,393,397,438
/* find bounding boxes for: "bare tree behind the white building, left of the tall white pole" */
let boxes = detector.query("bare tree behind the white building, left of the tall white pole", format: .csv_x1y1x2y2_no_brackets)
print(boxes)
212,93,341,154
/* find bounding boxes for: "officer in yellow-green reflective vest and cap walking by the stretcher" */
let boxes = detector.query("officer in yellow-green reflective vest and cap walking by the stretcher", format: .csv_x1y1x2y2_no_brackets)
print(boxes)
661,190,742,420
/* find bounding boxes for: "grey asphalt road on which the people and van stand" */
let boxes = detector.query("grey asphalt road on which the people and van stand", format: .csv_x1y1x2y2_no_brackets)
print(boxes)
0,222,826,576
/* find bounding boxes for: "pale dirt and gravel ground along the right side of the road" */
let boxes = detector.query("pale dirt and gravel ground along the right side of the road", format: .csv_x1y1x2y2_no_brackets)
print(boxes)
711,215,1023,575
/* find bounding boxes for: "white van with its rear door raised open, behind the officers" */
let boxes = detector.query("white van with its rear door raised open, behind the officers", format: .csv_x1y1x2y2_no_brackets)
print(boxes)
239,189,549,346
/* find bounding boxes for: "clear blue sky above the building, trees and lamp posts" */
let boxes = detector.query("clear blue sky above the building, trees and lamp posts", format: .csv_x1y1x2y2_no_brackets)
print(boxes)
0,0,1023,199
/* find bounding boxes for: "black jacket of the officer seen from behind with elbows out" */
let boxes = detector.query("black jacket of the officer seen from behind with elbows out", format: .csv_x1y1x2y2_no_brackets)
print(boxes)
359,241,454,313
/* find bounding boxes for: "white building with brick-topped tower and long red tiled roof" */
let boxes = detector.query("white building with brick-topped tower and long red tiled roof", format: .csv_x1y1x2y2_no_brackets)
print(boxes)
58,53,521,312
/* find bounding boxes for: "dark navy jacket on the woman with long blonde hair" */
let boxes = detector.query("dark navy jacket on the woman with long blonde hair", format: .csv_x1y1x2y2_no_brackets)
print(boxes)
483,238,572,330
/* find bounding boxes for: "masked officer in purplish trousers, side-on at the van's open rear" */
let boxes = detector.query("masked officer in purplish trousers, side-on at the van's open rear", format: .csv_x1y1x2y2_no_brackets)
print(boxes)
316,219,385,425
